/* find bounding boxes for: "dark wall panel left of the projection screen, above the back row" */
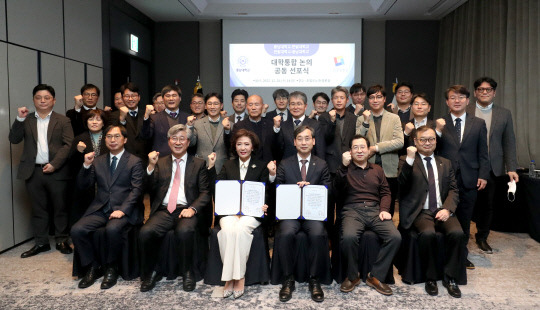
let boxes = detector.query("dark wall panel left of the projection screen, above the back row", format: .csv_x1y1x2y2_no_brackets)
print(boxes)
154,22,199,111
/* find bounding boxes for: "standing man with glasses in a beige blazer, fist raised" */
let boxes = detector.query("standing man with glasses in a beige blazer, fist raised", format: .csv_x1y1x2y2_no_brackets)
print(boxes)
356,85,403,215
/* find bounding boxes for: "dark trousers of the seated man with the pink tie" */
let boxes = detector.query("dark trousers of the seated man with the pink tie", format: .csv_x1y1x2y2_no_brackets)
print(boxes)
139,207,199,278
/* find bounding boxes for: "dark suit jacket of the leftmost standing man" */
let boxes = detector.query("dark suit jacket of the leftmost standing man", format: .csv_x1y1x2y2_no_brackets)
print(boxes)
9,111,73,180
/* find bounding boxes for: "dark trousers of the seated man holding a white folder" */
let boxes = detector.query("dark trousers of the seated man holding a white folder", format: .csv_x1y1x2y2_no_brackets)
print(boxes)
274,220,329,277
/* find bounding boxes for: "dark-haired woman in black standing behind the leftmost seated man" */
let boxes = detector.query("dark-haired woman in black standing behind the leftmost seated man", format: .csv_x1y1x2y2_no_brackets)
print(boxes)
70,109,109,224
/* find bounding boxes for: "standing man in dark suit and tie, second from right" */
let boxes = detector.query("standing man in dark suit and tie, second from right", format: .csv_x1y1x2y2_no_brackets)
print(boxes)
436,85,489,269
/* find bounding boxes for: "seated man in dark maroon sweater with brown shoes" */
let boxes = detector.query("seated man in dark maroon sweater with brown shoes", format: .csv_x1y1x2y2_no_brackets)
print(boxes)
333,135,401,295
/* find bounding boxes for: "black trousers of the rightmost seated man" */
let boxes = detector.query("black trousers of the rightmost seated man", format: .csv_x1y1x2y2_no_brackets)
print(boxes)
413,210,465,281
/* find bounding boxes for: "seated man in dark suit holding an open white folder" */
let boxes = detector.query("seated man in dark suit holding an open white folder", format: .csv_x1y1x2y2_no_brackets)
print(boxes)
268,126,330,302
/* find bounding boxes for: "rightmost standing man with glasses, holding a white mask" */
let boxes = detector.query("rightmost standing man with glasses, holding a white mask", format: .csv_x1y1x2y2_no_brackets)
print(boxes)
467,77,519,254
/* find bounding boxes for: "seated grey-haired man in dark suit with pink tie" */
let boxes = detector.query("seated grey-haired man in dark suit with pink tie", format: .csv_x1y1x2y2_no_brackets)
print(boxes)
139,124,211,292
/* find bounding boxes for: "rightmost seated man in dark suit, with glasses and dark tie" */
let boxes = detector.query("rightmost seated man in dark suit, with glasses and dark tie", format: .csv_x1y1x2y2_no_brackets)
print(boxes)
398,126,465,298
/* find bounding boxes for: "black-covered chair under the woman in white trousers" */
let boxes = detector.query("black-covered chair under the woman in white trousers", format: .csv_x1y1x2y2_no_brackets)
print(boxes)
204,225,270,285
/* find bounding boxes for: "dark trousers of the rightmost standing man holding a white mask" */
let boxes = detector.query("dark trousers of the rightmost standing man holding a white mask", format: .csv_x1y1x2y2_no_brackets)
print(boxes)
474,171,500,240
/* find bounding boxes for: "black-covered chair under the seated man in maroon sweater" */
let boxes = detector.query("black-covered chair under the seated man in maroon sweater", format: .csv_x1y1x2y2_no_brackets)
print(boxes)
332,228,395,284
